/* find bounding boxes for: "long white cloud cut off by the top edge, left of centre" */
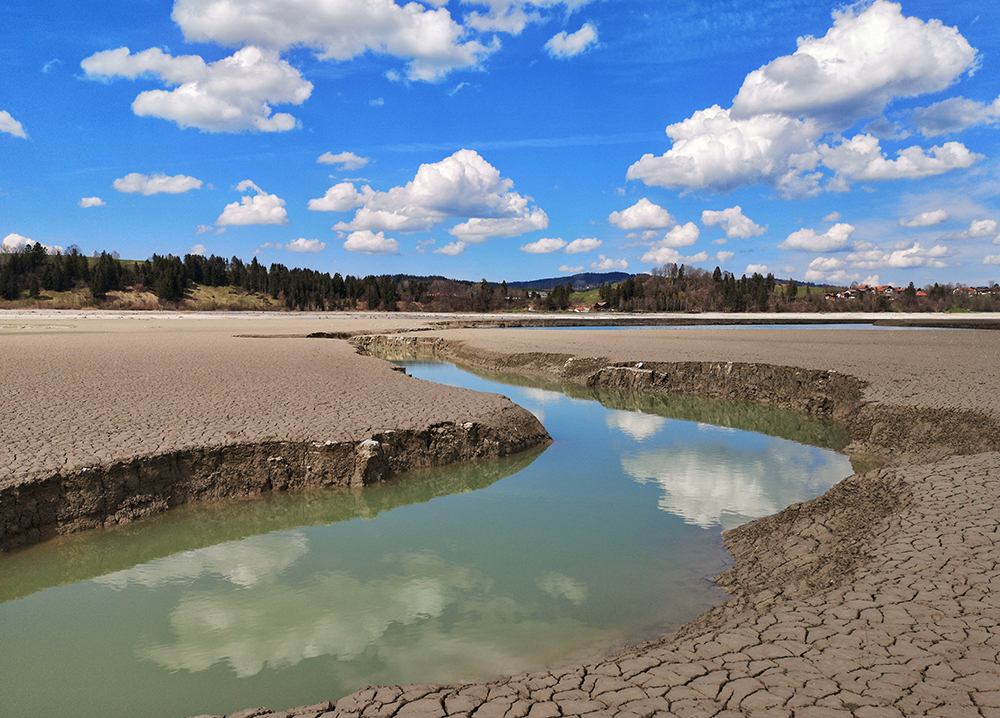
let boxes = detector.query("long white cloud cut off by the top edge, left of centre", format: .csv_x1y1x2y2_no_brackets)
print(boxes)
173,0,499,80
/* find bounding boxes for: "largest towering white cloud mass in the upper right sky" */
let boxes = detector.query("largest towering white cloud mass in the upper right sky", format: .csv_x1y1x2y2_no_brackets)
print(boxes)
627,0,979,197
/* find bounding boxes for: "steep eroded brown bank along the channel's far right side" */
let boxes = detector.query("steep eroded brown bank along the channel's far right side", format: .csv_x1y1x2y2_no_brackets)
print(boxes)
350,335,1000,465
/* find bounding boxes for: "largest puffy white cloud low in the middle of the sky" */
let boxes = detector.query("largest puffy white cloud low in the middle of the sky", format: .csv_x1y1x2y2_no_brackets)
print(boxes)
332,150,549,244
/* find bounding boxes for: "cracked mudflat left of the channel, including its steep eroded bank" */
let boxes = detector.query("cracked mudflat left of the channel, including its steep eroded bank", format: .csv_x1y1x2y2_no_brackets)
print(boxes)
0,313,545,551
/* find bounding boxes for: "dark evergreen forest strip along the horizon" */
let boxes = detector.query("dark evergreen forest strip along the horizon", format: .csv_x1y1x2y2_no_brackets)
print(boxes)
0,244,1000,313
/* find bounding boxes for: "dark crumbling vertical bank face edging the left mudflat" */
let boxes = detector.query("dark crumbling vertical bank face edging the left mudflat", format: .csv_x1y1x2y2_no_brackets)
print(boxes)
0,404,551,553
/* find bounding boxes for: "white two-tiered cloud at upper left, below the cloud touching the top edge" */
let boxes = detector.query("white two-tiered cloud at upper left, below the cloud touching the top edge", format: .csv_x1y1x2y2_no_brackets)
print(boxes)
80,46,312,132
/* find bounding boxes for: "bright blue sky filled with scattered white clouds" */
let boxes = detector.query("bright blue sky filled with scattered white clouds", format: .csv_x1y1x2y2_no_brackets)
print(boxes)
0,0,1000,287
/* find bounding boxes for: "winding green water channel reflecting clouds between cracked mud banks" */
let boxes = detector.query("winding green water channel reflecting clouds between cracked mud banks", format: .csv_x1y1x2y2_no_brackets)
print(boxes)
0,364,851,718
